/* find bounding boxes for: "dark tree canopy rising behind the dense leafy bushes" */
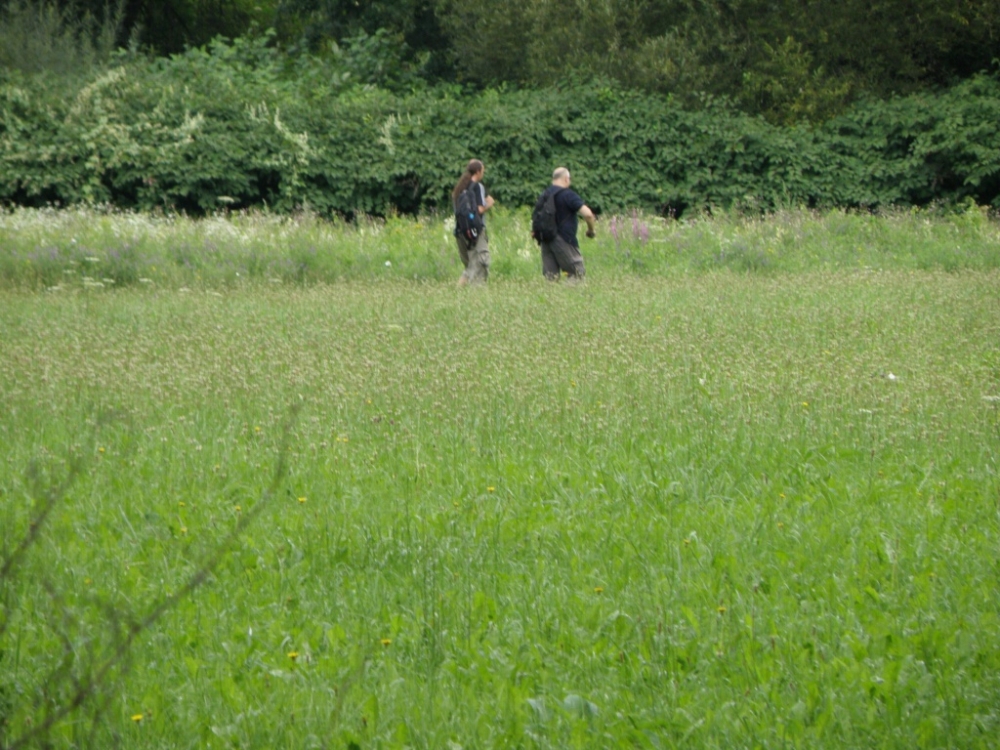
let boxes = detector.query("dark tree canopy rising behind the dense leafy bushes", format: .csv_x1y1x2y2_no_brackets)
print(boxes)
0,0,1000,124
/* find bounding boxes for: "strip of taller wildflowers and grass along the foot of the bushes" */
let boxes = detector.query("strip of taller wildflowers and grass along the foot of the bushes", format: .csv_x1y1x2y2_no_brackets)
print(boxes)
0,207,1000,291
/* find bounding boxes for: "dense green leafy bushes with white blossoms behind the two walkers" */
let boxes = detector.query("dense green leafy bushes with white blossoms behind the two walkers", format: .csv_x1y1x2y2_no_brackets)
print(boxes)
0,41,1000,215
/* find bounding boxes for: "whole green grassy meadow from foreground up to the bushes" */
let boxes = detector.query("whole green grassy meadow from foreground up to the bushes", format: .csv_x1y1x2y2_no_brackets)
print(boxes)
0,213,1000,749
